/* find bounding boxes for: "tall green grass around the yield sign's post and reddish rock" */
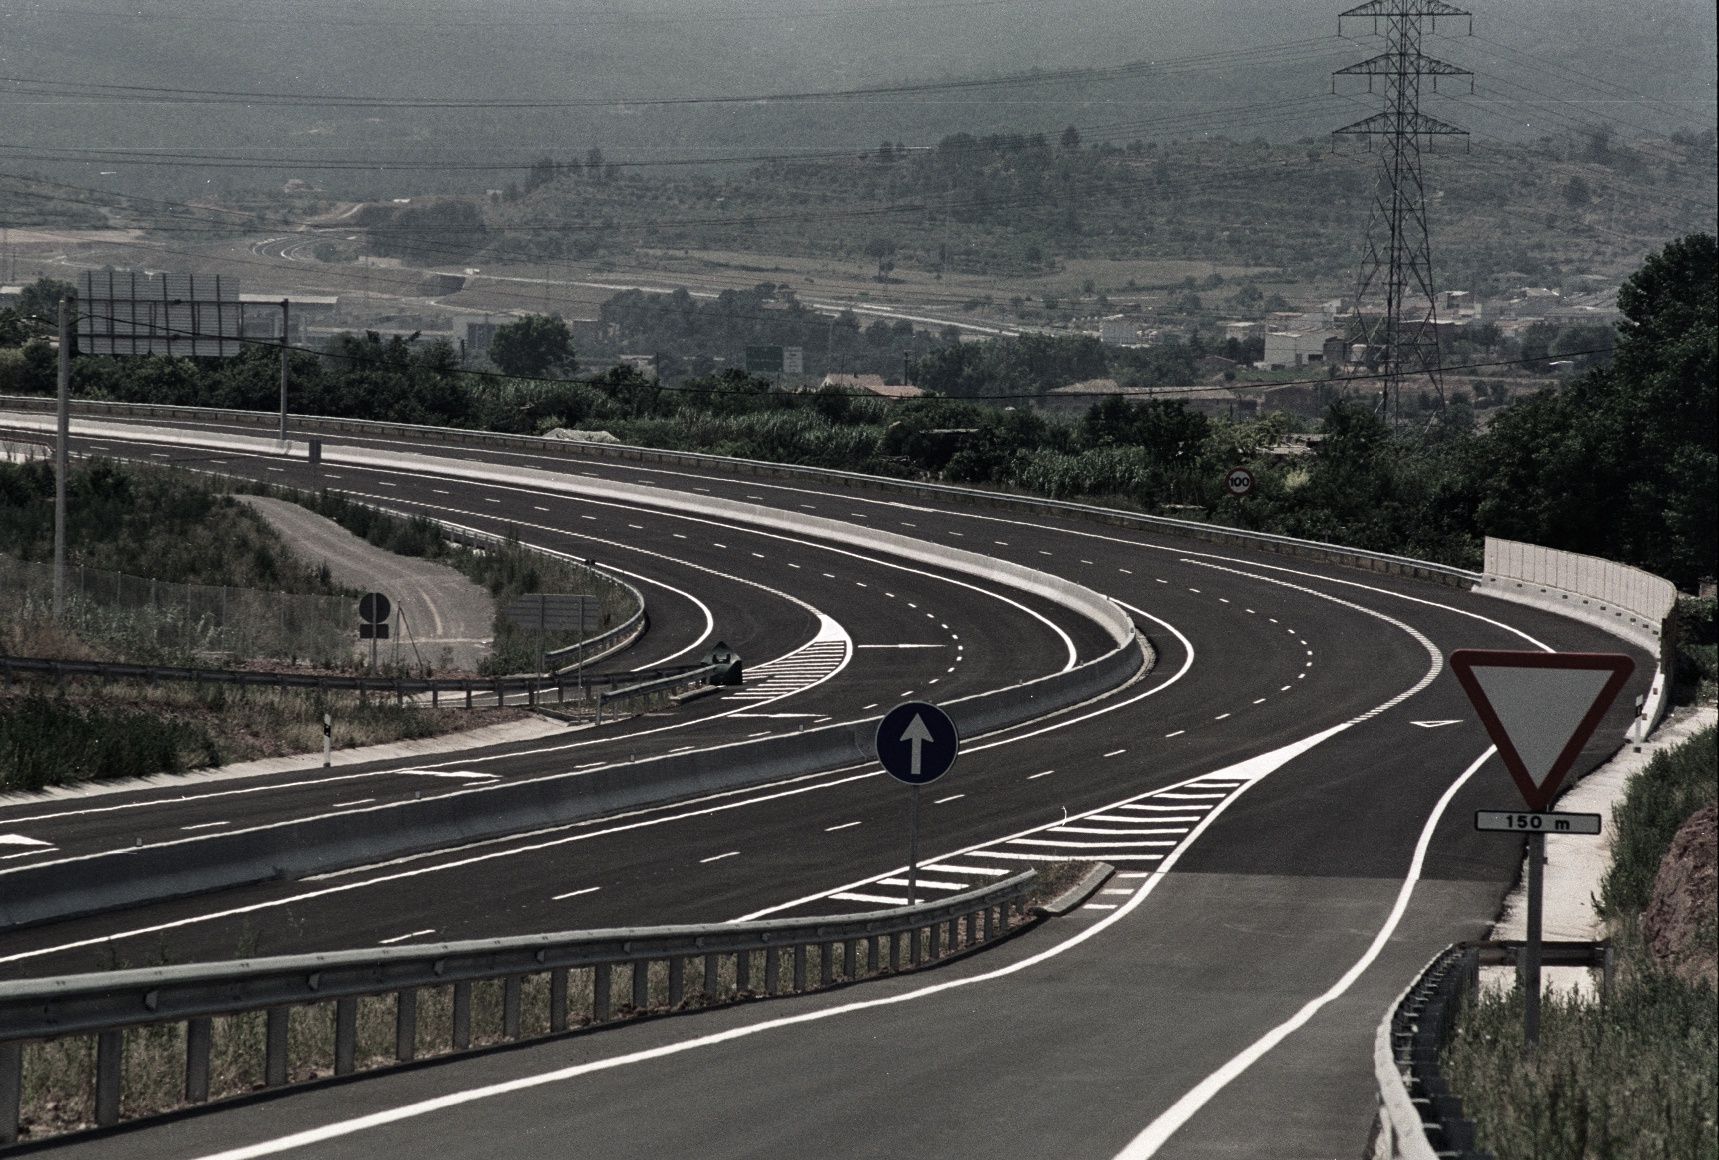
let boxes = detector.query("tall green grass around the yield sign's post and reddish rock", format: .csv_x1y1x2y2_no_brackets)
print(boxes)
1444,729,1719,1160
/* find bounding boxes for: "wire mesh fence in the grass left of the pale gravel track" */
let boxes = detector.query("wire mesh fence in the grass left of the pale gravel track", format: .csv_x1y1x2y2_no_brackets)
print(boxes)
0,555,356,667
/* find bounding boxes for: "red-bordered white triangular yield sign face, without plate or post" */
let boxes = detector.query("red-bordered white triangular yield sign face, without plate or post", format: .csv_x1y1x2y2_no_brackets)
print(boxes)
1451,648,1635,809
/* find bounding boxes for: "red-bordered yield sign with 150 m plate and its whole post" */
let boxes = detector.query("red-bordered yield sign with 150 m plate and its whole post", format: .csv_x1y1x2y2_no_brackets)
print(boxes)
1451,648,1635,1052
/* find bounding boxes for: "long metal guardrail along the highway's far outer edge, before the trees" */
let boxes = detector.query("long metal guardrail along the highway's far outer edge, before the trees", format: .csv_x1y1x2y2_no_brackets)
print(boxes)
0,395,1480,588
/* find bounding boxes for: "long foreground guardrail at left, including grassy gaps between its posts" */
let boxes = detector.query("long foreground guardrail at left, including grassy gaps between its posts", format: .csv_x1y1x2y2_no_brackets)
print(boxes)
0,870,1037,1145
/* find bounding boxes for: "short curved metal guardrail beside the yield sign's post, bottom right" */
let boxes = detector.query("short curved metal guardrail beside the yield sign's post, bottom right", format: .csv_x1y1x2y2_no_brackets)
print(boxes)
1370,942,1612,1160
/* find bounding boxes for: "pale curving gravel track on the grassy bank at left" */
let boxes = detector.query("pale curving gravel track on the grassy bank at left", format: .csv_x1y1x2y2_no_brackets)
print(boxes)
237,495,495,674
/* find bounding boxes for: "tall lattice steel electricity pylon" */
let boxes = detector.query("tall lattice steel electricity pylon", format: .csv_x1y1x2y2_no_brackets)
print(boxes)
1331,0,1473,419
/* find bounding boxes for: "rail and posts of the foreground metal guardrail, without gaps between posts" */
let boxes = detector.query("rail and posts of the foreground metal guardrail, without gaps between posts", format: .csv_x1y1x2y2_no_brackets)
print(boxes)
0,870,1037,1145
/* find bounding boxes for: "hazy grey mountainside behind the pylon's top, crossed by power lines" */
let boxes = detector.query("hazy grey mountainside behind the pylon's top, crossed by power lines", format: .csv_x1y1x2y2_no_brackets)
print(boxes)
0,0,1716,198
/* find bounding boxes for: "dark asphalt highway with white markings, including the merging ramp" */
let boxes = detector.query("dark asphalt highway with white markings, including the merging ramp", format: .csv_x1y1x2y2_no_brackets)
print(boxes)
0,409,1654,1157
